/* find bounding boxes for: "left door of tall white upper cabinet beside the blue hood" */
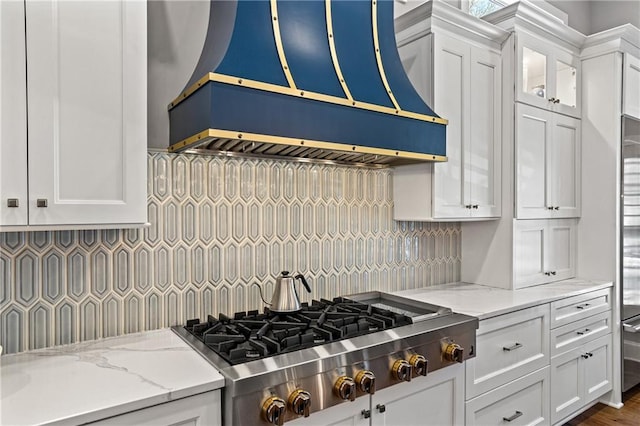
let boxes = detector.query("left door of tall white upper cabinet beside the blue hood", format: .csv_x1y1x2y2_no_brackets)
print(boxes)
434,34,470,217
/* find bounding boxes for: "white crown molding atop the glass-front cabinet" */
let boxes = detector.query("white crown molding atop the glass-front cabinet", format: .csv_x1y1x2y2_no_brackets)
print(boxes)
482,0,586,53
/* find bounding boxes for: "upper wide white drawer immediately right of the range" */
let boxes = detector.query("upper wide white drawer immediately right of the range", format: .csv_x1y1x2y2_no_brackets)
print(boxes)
465,304,549,399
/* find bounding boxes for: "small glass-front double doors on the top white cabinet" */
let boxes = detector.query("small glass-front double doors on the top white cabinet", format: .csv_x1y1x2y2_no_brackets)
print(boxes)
516,32,580,117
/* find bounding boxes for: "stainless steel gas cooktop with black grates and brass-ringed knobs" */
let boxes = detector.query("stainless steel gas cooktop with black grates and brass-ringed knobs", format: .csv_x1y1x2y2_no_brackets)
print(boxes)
173,292,478,425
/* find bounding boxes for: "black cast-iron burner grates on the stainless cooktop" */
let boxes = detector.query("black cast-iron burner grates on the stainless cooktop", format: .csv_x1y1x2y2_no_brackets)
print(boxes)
184,297,412,364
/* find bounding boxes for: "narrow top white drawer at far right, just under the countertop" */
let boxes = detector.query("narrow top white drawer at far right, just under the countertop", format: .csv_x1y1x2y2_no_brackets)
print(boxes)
551,288,611,328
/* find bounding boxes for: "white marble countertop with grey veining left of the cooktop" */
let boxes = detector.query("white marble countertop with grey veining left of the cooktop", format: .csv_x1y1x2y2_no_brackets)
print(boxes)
0,329,224,426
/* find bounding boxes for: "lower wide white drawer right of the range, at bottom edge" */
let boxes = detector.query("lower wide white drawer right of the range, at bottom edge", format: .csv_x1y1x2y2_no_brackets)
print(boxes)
465,367,549,426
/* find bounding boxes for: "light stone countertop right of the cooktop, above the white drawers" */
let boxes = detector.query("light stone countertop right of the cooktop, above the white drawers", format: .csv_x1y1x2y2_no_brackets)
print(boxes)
393,278,613,320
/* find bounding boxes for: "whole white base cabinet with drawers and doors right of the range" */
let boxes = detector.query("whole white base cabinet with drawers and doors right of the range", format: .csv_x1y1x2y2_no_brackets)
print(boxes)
465,288,613,426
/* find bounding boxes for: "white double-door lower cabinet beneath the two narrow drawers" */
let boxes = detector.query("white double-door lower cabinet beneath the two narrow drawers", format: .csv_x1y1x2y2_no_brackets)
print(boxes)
551,334,612,424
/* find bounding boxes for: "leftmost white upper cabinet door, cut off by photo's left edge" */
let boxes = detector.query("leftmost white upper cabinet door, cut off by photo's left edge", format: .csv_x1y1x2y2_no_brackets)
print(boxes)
0,1,28,226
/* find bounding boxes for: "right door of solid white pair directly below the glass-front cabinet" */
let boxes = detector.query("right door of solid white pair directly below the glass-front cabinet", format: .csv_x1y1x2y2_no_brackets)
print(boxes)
549,114,581,217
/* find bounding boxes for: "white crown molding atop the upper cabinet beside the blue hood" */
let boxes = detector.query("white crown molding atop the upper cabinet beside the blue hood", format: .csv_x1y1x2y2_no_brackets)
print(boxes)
394,0,509,47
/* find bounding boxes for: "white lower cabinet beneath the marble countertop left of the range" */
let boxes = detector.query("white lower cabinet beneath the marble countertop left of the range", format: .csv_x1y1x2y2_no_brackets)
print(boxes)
91,390,222,426
